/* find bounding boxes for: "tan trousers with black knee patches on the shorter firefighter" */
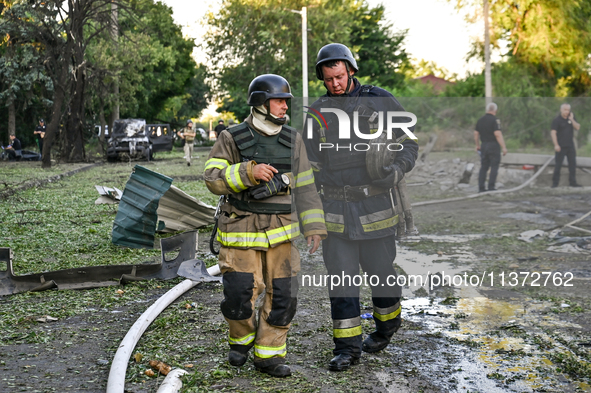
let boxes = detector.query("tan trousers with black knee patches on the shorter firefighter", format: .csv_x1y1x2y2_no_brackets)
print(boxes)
219,242,300,367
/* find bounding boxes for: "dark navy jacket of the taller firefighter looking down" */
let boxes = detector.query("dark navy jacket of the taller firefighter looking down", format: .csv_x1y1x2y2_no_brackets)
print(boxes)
304,78,418,240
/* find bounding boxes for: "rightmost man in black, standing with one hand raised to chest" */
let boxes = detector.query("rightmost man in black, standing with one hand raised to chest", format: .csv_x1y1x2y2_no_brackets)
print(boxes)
550,104,581,188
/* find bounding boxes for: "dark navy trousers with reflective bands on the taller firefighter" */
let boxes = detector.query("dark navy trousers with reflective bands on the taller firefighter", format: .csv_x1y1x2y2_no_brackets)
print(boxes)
322,235,402,357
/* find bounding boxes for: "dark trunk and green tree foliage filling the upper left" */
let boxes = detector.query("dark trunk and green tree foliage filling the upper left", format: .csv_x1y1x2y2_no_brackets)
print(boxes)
0,0,209,167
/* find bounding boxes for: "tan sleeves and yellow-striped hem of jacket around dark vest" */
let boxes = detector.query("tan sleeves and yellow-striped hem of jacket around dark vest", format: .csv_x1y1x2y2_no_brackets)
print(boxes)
203,117,327,250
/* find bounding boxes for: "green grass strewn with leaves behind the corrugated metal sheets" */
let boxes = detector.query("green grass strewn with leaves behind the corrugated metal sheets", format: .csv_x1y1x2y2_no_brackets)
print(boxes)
0,152,217,274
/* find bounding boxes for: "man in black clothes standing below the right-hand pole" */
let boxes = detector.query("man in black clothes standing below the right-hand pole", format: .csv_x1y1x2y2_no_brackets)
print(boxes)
474,102,507,192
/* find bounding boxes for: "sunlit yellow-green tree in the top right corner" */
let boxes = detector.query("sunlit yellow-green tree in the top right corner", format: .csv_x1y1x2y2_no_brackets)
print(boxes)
448,0,591,95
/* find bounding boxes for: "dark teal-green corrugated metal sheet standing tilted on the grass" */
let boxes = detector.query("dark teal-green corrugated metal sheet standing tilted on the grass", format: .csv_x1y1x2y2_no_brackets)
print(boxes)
112,165,172,248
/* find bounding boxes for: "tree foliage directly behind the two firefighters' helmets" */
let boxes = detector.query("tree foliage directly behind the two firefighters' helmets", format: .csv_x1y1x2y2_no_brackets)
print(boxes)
206,0,408,119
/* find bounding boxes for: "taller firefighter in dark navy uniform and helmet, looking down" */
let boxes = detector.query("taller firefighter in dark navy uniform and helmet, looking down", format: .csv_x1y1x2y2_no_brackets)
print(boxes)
304,43,418,371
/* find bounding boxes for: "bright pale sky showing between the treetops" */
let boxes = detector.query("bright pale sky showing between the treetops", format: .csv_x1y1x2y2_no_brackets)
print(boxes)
162,0,484,77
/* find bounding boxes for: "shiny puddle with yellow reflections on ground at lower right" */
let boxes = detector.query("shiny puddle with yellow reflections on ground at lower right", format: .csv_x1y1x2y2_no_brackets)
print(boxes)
390,240,591,392
